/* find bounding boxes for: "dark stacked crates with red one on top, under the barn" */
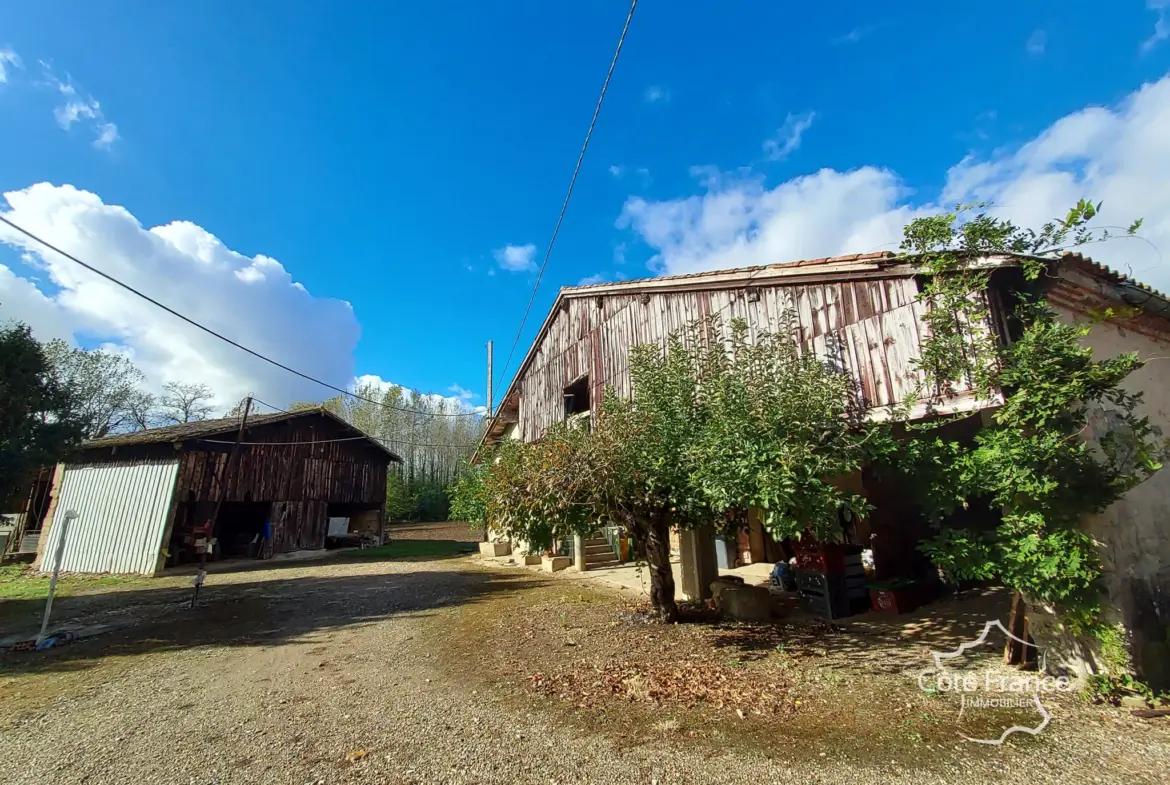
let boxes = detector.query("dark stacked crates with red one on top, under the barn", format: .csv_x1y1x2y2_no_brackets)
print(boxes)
796,543,869,619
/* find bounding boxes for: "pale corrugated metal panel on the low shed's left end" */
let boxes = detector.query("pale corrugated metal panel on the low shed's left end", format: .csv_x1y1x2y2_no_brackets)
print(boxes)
41,457,179,576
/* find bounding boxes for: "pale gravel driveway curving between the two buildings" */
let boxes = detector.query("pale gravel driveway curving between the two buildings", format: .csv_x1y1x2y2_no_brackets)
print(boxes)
0,547,1170,785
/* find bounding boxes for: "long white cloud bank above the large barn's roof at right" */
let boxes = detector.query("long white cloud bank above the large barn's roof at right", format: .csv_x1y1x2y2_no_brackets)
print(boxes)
618,76,1170,290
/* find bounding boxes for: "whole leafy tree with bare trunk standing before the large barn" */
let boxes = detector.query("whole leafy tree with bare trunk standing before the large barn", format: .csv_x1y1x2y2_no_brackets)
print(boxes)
483,321,886,620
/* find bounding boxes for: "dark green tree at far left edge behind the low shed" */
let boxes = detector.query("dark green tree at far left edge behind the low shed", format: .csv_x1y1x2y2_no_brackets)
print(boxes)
0,324,87,498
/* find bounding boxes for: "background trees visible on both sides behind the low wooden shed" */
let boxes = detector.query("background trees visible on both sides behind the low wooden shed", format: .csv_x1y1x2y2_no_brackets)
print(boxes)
0,323,483,521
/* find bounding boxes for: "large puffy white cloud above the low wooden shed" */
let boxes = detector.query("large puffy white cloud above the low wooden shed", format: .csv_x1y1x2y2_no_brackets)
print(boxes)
0,183,359,408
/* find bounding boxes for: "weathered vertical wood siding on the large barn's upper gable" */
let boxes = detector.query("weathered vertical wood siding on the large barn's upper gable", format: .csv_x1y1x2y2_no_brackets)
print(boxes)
518,276,973,441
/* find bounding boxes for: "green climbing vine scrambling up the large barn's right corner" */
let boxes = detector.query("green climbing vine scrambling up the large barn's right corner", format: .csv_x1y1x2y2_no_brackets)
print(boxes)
894,201,1165,633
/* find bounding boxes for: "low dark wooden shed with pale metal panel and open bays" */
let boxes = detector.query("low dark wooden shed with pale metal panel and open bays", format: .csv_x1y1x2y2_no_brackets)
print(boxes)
36,409,401,574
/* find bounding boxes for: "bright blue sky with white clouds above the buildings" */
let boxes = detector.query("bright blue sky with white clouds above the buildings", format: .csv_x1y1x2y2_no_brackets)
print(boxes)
0,0,1170,404
